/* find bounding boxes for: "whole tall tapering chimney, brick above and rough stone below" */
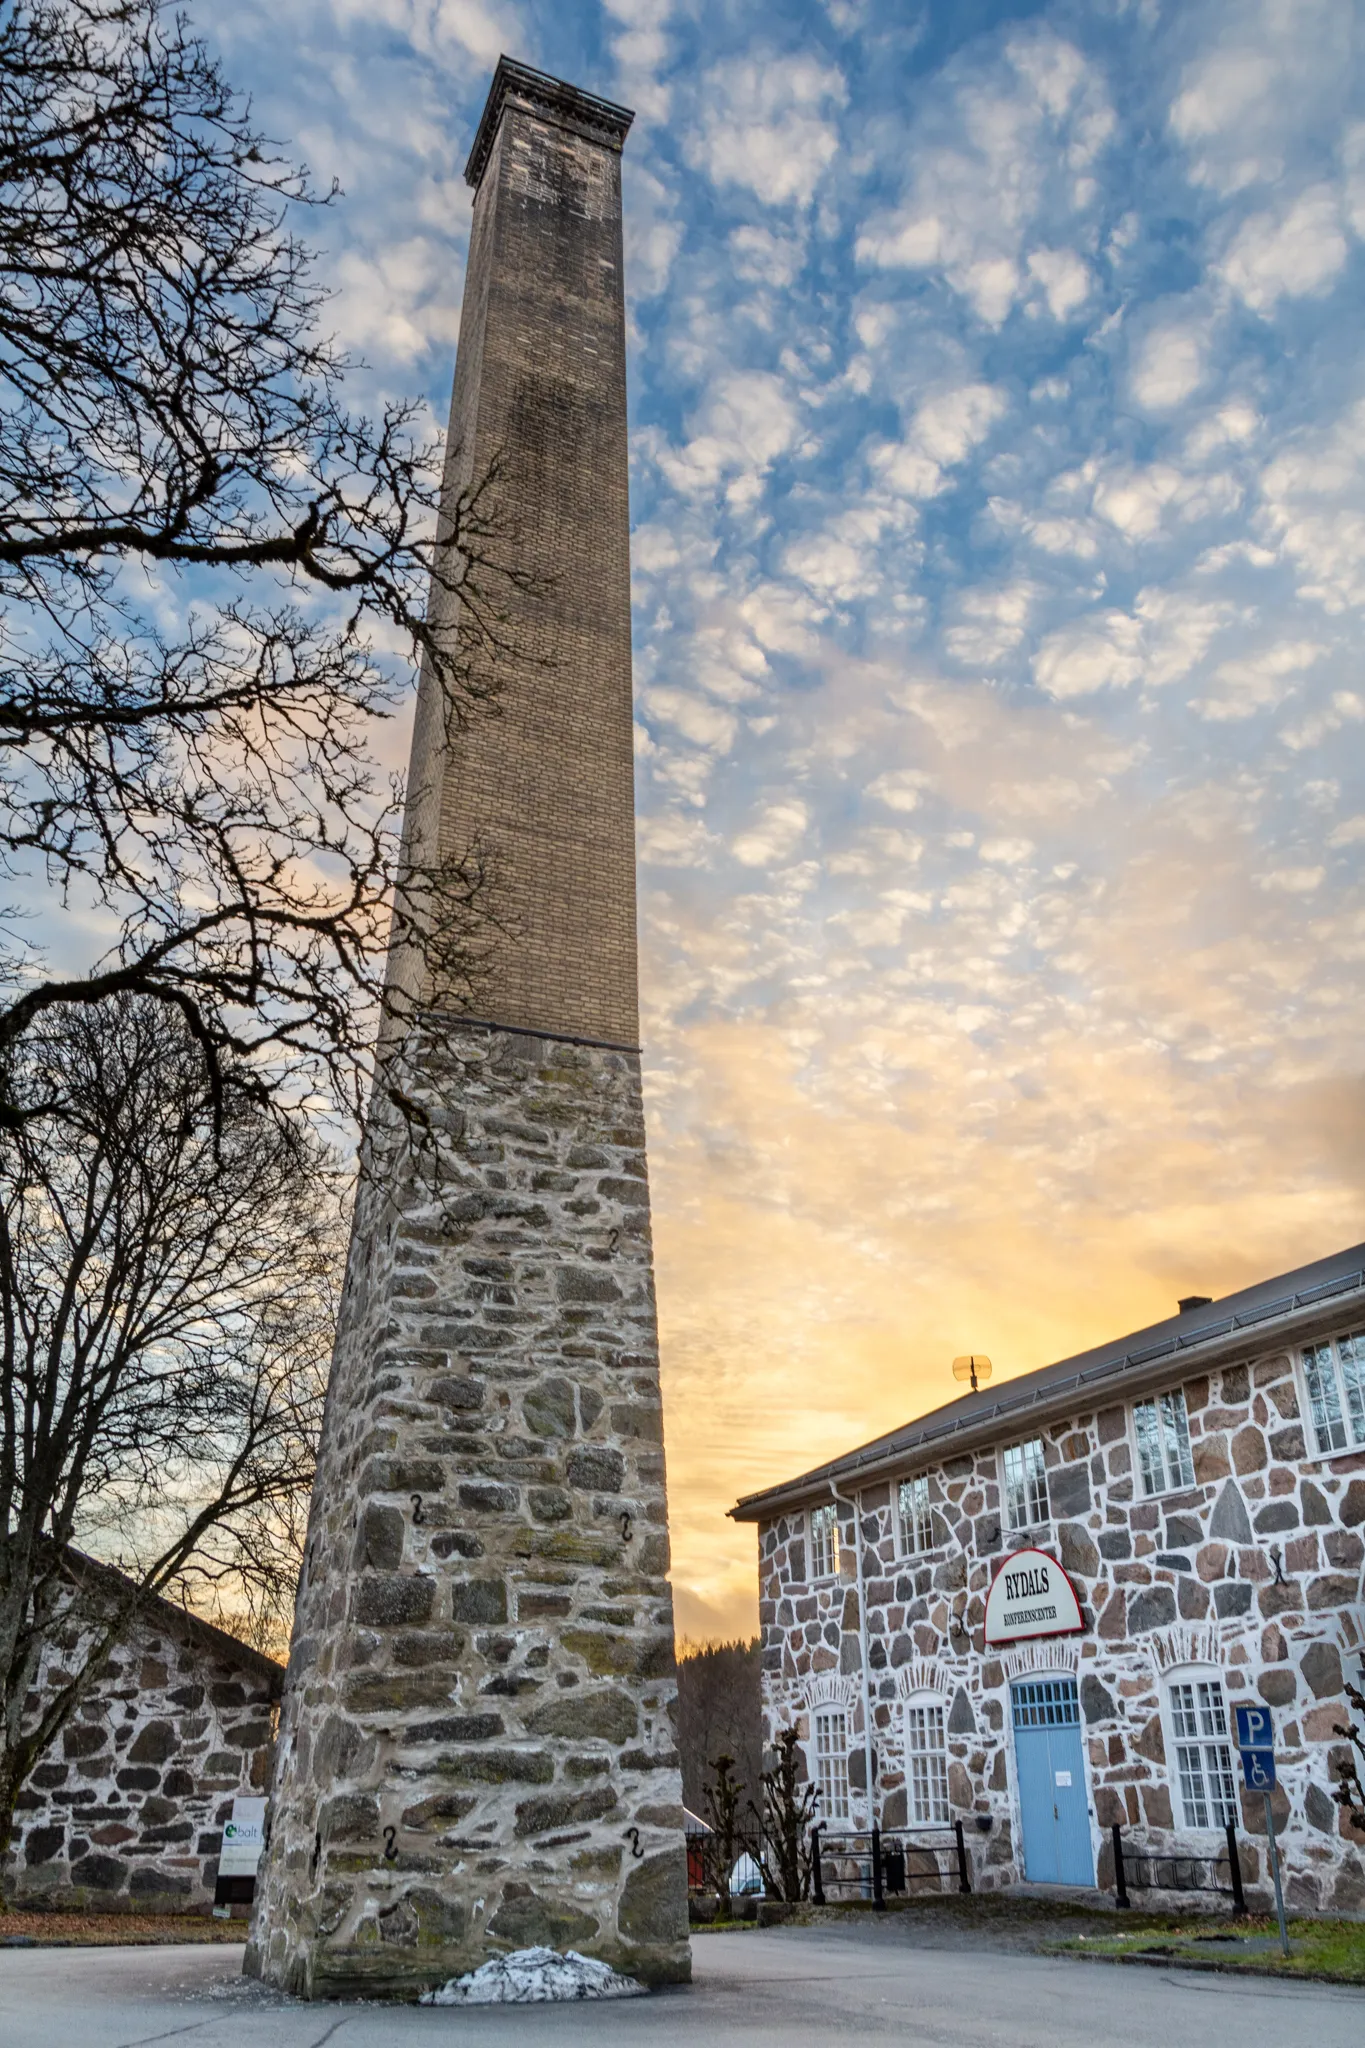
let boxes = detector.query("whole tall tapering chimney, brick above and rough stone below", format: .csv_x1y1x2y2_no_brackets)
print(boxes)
248,59,690,1997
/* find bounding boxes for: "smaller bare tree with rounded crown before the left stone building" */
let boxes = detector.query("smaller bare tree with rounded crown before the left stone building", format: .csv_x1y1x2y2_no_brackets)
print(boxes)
0,995,340,1884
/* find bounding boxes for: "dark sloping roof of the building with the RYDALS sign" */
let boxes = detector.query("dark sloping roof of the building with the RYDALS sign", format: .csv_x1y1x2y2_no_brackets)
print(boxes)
731,1245,1365,1522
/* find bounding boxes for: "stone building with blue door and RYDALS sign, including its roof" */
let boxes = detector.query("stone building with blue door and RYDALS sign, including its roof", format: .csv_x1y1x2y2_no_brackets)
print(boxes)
733,1245,1365,1913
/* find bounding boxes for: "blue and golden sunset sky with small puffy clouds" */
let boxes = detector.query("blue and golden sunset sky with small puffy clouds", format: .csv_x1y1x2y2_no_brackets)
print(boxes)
224,0,1365,1634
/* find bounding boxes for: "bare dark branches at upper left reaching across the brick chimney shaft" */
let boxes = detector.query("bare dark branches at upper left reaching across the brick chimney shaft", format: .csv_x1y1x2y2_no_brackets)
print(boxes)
0,0,515,1118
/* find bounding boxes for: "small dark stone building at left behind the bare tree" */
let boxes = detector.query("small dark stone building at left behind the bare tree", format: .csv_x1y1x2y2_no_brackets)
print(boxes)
10,1559,284,1913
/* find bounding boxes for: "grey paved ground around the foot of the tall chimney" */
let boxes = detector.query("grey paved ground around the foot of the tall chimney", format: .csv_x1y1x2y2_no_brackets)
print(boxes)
0,1925,1365,2048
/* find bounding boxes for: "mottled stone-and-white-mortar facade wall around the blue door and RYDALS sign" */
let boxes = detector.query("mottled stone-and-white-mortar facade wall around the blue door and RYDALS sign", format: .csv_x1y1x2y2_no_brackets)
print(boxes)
759,1352,1365,1913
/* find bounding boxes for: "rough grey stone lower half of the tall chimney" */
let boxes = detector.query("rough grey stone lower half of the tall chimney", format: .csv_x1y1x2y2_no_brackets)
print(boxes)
248,1018,688,1997
